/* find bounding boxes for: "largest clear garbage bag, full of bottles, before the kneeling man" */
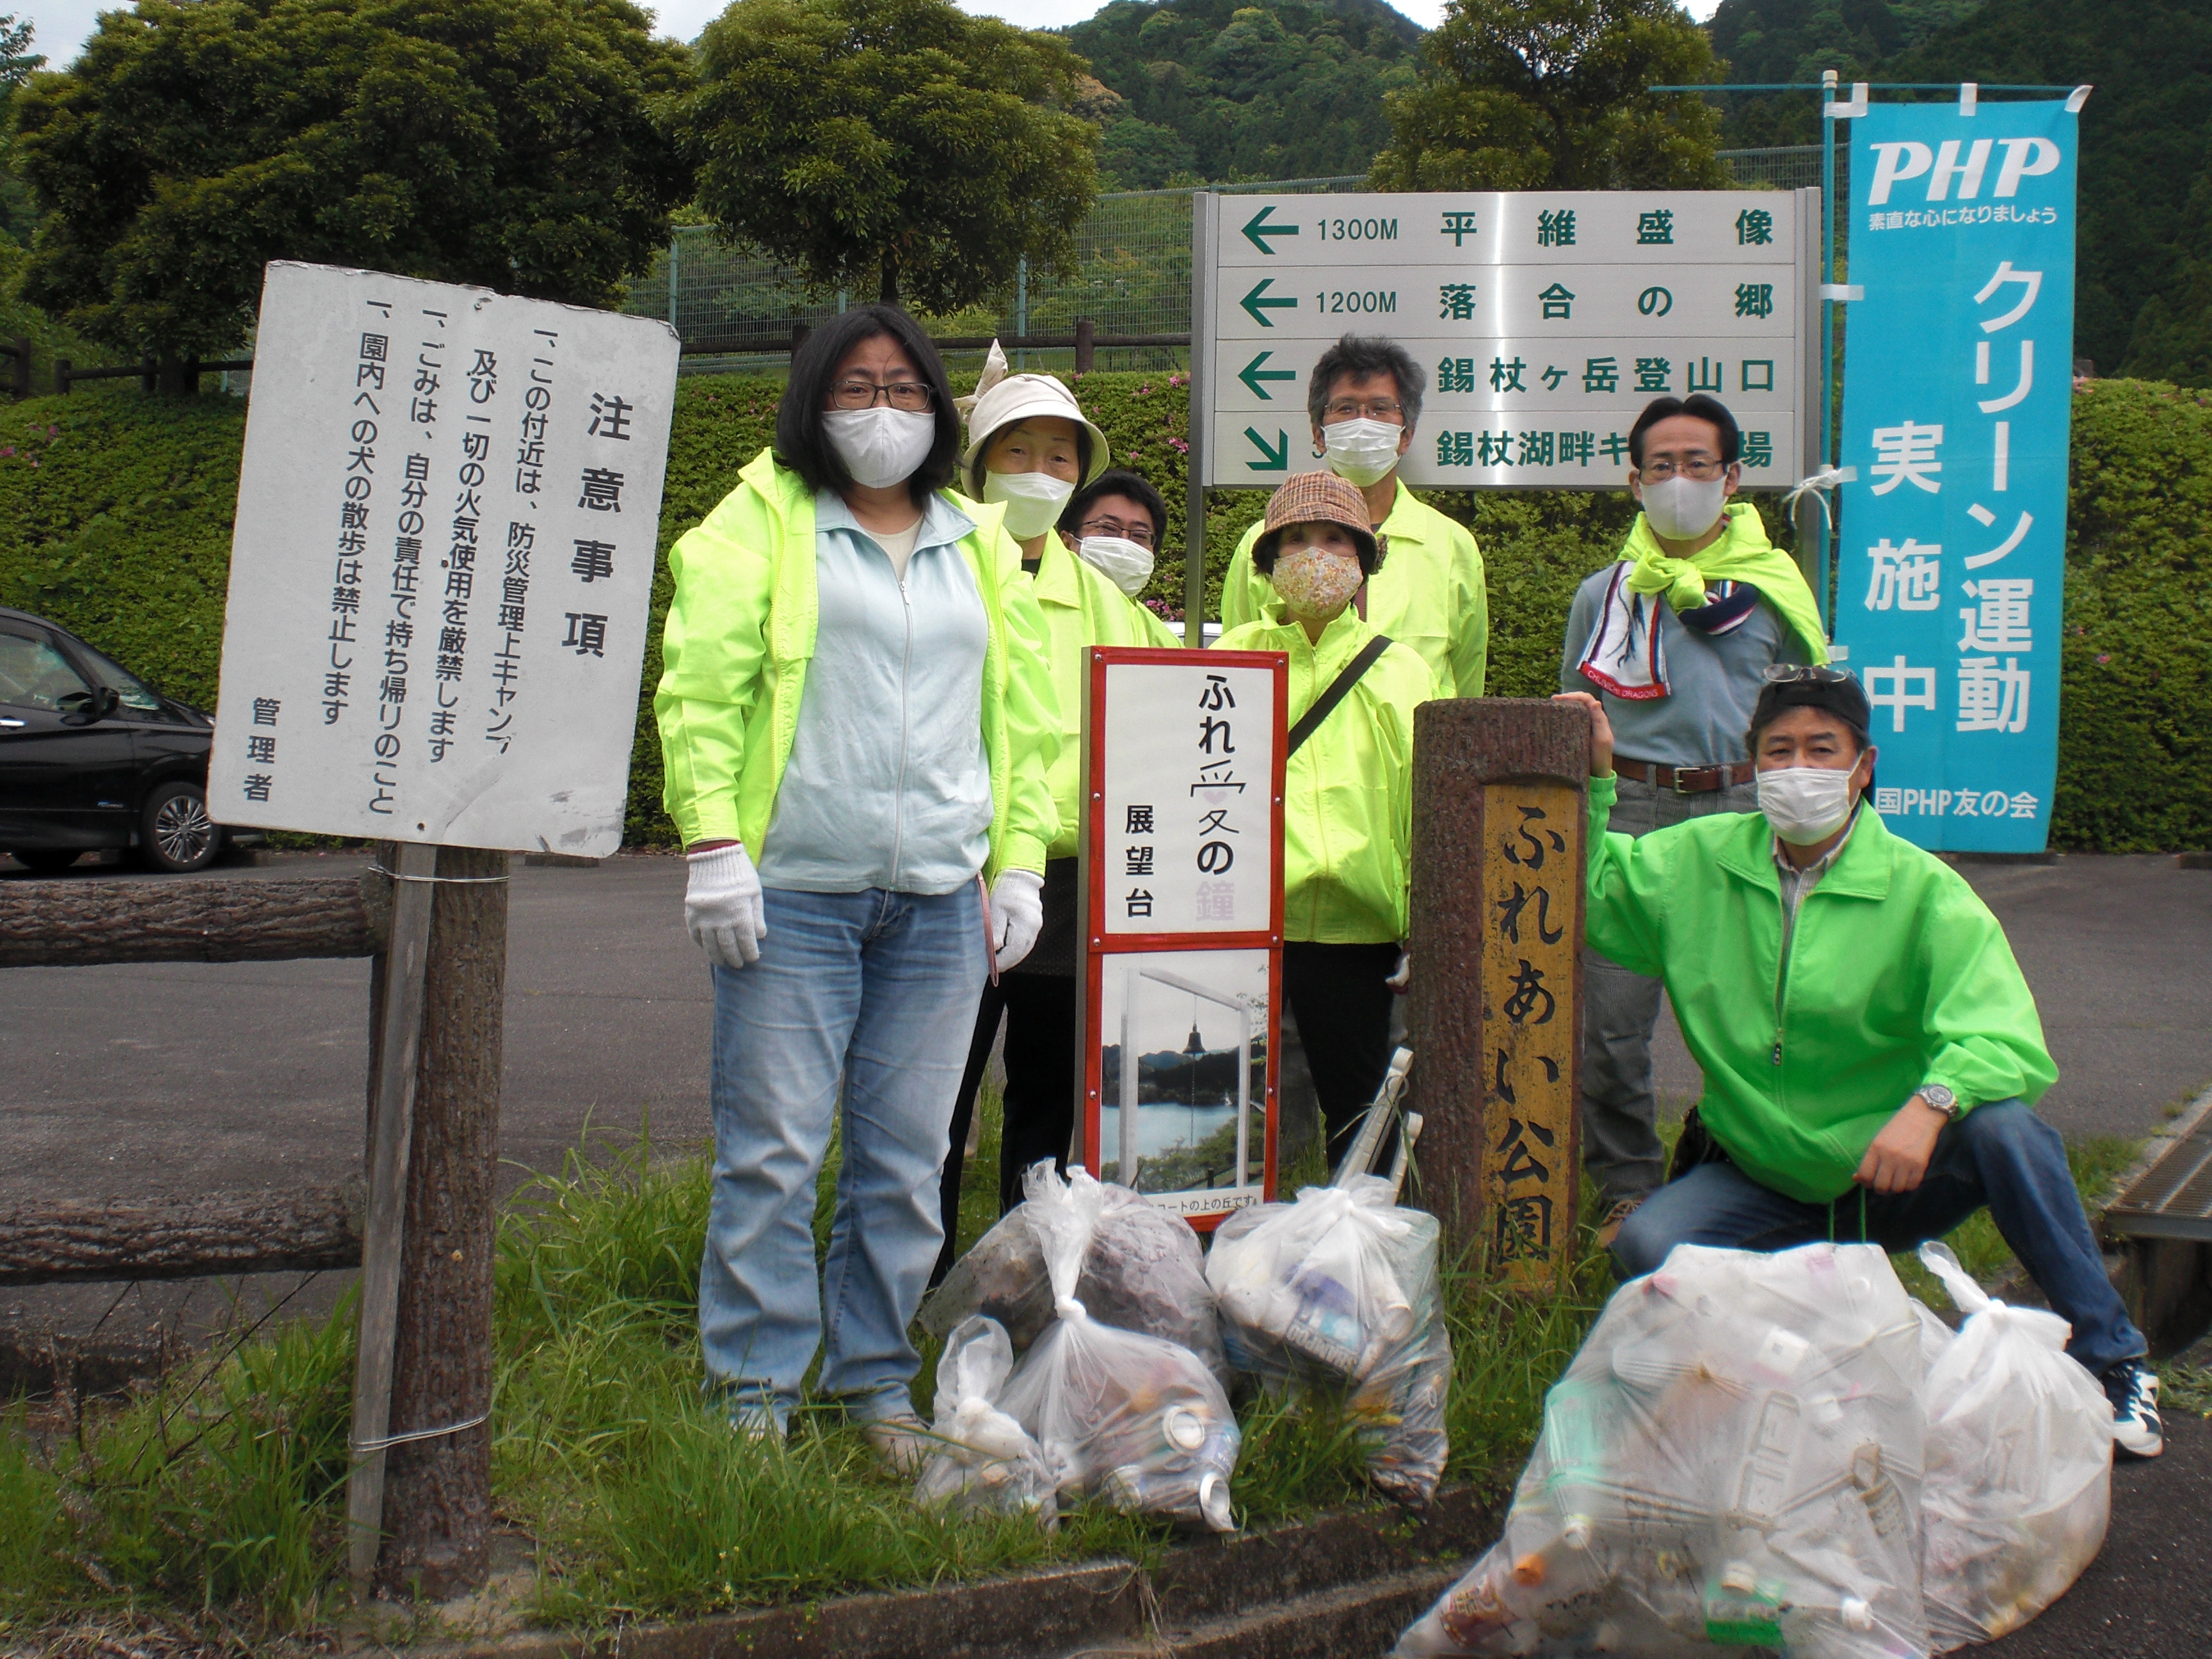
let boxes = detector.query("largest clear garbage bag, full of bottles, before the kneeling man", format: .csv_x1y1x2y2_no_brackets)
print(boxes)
1396,1243,1927,1659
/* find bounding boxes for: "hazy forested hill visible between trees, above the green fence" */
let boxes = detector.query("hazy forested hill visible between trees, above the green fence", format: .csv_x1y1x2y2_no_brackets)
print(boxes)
1066,0,1420,190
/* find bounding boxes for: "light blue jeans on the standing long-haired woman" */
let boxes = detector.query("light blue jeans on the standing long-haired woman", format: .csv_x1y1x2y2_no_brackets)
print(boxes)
699,885,986,1422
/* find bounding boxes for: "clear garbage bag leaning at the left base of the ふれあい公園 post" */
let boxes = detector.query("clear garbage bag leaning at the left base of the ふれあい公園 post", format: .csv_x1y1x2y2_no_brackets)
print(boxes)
1206,1174,1451,1507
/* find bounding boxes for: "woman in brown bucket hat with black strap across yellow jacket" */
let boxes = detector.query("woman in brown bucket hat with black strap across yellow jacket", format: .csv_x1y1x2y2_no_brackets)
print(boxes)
1219,474,1442,1164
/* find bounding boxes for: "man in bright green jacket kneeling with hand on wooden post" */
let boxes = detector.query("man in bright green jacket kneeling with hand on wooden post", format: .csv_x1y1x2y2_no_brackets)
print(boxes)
1559,664,2163,1458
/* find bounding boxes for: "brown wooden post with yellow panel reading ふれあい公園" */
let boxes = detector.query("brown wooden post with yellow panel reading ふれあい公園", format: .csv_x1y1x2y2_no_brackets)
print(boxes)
1409,697,1591,1283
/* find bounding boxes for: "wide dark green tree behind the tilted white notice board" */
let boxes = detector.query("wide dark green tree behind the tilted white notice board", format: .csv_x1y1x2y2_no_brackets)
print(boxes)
15,0,690,389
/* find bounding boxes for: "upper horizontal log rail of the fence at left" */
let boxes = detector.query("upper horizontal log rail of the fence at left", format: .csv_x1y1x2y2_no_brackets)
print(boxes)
0,876,389,966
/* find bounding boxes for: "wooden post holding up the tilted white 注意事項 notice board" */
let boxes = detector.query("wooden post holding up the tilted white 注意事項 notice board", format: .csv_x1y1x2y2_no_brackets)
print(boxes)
376,847,506,1601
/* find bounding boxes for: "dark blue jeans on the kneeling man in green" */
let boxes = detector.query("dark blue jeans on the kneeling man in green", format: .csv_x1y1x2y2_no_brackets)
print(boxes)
1612,1100,2148,1374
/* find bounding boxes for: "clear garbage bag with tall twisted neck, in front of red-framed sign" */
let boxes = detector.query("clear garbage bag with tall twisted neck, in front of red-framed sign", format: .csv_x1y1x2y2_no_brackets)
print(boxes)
1000,1164,1243,1533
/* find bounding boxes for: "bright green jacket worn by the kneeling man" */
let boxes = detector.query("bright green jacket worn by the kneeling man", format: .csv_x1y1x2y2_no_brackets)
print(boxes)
1588,779,2060,1203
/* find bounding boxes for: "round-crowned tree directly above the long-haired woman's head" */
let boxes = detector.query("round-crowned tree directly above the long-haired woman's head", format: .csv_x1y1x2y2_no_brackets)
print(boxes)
679,0,1097,312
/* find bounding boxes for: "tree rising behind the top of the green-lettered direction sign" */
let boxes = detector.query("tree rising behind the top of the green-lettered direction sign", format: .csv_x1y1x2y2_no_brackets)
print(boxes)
1369,0,1730,190
